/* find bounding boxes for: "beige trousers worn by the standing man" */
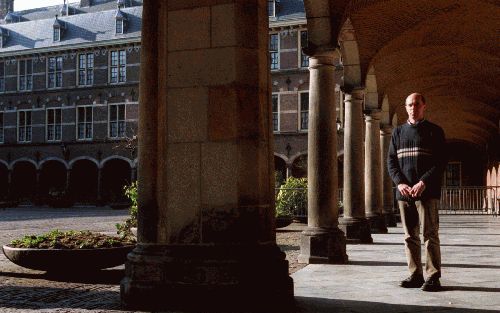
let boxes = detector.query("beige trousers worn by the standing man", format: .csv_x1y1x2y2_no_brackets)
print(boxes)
398,199,441,278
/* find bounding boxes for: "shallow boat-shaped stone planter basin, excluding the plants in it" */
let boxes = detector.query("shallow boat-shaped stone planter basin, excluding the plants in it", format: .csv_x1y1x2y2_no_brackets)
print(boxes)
2,245,135,272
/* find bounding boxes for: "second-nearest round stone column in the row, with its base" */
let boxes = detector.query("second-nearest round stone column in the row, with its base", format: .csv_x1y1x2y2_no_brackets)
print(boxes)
340,89,373,243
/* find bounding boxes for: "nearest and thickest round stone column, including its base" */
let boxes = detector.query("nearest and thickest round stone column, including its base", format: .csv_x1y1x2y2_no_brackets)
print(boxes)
299,51,347,264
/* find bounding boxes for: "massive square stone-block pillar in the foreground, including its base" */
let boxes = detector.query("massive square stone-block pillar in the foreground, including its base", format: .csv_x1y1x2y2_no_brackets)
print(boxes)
120,0,293,312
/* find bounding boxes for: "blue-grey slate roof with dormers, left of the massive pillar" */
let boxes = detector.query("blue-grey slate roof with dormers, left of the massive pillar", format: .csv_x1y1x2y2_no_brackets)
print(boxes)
0,6,142,56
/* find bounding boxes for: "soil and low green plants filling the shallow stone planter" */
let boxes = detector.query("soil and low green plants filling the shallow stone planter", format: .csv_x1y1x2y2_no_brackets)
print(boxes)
9,230,135,249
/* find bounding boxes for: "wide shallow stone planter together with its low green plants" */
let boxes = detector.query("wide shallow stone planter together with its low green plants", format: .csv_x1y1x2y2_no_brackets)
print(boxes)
2,230,135,274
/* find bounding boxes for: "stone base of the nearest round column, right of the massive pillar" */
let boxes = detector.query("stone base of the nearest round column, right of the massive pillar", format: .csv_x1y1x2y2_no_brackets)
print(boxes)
298,227,348,264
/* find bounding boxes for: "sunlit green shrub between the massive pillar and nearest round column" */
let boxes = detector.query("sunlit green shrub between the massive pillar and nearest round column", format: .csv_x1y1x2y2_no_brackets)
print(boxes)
276,177,307,217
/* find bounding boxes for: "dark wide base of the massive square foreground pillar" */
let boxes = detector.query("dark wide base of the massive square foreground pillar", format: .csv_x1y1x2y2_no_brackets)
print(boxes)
120,244,294,312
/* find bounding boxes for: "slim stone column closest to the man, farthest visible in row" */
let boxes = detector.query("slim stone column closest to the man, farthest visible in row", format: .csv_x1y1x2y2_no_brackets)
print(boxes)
380,125,397,227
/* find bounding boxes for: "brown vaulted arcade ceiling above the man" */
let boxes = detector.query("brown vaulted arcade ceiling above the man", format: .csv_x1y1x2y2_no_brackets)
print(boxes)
304,0,500,149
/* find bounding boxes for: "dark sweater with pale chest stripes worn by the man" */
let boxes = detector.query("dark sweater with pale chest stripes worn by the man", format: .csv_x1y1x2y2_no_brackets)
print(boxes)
387,120,447,201
